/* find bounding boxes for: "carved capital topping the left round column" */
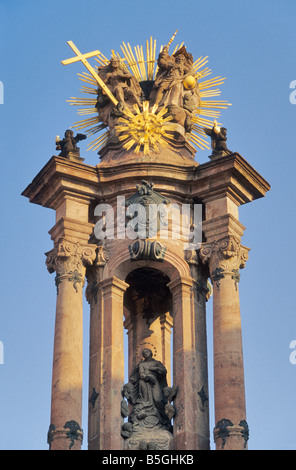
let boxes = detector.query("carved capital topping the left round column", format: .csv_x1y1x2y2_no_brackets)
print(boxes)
46,238,97,293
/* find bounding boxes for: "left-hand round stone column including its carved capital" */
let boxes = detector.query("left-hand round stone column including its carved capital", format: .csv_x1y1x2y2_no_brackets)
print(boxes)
46,238,97,450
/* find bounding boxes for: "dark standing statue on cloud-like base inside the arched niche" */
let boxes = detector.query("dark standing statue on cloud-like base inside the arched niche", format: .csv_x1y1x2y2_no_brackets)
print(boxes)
121,348,178,450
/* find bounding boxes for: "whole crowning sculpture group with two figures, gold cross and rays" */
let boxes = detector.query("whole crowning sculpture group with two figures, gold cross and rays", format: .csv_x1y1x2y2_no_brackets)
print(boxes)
62,31,230,155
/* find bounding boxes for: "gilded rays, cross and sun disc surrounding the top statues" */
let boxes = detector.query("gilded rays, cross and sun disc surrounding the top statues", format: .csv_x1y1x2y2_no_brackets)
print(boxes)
62,33,230,154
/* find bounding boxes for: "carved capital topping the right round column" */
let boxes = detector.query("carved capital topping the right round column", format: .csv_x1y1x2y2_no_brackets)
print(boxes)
199,235,250,289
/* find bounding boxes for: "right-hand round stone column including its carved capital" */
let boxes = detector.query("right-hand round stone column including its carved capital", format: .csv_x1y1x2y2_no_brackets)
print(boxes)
199,235,249,450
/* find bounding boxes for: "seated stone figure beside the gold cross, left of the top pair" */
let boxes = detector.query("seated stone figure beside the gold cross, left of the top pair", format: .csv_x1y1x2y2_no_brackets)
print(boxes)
96,56,143,129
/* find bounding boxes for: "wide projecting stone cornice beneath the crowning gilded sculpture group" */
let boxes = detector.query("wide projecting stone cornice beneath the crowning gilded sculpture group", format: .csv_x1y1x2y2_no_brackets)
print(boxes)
22,153,270,209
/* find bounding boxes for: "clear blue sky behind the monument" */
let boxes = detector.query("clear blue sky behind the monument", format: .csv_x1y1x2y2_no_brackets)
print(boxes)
0,0,296,450
